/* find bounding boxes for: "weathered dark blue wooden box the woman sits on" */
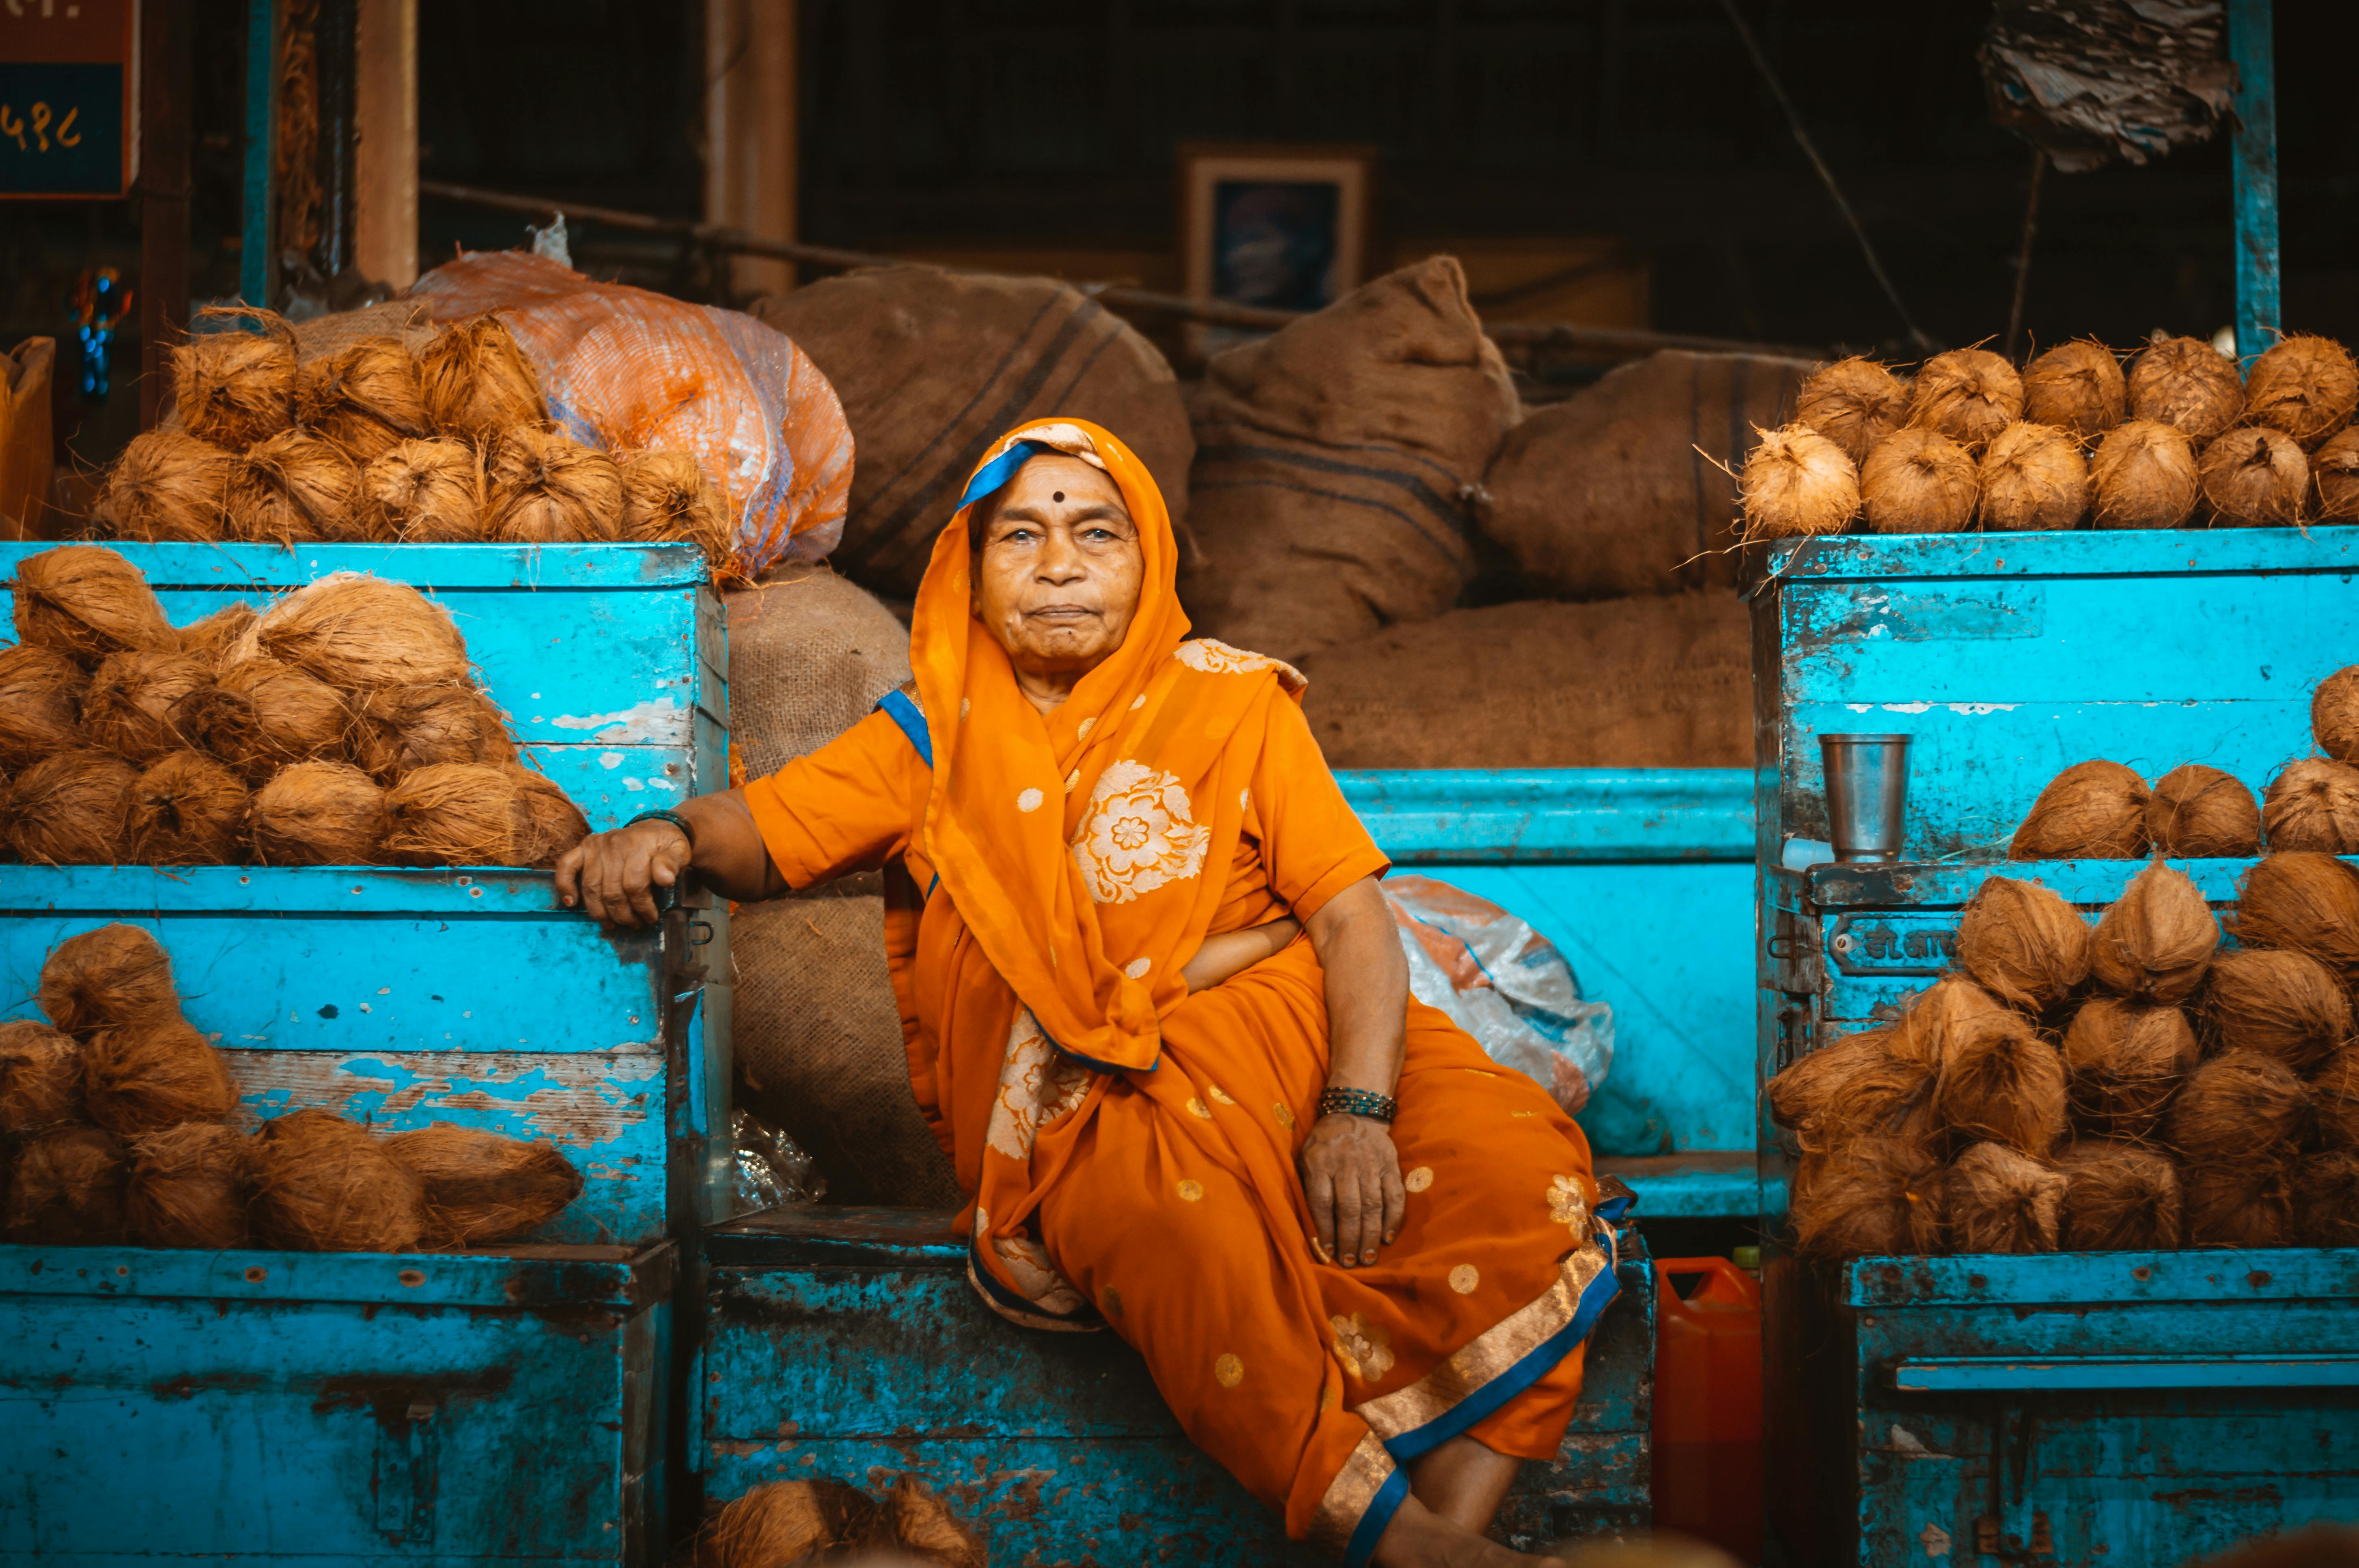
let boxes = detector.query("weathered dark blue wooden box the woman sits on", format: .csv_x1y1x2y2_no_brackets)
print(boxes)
691,1210,1654,1568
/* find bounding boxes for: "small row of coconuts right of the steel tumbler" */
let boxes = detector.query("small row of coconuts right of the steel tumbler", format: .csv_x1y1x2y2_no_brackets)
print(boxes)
2008,665,2359,860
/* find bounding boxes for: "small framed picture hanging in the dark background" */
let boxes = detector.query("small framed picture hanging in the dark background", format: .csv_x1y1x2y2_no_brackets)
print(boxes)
1180,144,1375,354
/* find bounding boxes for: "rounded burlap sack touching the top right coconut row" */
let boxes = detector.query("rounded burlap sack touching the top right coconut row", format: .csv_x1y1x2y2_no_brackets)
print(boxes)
1474,349,1814,599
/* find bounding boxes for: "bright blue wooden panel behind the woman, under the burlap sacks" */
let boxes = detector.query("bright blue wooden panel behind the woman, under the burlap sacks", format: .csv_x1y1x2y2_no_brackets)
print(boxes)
1335,769,1755,1219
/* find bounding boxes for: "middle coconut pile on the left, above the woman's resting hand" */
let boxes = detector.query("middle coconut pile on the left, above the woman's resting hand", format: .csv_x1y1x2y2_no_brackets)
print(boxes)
0,545,590,865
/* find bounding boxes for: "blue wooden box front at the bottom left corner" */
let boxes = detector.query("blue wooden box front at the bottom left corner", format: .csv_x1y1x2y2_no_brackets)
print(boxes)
0,1245,675,1568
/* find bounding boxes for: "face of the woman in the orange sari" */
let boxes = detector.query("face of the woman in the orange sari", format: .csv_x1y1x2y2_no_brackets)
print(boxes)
974,453,1146,677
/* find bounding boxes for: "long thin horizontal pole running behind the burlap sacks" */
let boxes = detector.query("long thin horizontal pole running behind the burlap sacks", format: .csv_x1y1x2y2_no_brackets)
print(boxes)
418,179,1826,358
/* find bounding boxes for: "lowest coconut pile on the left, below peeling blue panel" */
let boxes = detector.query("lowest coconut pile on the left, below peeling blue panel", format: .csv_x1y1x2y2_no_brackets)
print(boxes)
0,924,583,1252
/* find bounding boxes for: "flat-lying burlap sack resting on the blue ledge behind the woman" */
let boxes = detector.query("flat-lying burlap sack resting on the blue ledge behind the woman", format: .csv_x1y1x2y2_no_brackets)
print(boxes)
1302,592,1753,769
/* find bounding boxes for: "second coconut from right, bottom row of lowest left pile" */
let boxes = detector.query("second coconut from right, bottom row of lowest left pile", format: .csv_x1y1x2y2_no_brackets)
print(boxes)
246,1110,424,1252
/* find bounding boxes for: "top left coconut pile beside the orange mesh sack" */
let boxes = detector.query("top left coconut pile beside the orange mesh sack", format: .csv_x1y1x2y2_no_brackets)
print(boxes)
101,309,736,571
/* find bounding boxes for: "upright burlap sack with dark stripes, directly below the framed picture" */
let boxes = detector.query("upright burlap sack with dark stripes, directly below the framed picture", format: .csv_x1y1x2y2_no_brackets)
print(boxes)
1180,257,1521,660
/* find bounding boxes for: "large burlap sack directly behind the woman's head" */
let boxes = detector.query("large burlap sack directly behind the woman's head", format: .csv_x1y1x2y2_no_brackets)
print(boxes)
752,264,1196,596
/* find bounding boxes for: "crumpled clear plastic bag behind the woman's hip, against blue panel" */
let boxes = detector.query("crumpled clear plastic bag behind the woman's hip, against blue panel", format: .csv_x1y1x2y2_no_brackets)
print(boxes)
1385,877,1614,1115
